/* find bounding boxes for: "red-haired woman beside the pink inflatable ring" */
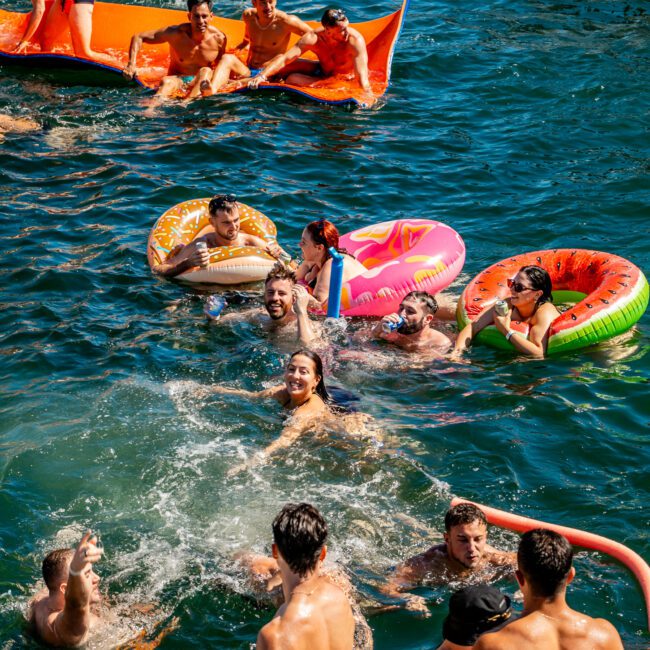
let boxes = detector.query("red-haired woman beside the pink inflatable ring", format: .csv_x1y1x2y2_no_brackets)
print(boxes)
296,219,368,308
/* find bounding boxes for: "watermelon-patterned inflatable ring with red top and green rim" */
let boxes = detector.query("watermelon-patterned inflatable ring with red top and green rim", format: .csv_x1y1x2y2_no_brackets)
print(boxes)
456,248,648,354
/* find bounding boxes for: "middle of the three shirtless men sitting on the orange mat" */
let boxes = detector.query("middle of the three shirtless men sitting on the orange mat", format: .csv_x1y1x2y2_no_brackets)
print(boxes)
201,0,311,95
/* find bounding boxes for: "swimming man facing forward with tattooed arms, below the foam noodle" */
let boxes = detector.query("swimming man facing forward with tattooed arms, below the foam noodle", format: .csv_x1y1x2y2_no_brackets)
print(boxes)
382,503,516,616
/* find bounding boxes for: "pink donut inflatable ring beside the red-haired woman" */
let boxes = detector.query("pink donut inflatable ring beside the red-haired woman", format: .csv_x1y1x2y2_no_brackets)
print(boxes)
320,219,465,316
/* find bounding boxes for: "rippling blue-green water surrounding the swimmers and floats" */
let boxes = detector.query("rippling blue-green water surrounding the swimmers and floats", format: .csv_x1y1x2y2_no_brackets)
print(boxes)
0,0,650,649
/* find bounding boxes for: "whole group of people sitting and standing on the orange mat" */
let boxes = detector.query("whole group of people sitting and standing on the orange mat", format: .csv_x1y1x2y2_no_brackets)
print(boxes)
14,0,372,107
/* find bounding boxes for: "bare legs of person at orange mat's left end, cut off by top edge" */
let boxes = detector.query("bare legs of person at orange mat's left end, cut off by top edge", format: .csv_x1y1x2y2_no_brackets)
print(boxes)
41,0,119,66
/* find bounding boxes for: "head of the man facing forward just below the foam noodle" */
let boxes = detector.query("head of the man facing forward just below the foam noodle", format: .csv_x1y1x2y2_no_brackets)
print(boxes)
444,503,487,569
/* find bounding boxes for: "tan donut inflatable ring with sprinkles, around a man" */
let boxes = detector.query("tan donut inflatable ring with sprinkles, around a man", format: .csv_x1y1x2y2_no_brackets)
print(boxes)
147,199,277,284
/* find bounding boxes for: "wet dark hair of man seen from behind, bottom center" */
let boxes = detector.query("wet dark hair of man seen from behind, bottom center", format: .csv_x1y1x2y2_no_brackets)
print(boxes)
273,503,327,577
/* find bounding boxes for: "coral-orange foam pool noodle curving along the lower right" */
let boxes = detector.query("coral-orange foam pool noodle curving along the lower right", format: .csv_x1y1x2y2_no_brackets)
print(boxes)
451,498,650,630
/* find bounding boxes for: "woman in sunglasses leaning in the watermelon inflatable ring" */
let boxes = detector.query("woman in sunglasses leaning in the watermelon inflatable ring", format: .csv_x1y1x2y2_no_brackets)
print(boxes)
453,266,560,358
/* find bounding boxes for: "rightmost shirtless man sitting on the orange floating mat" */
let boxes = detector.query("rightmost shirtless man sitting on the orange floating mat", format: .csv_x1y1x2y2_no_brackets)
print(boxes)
248,9,372,94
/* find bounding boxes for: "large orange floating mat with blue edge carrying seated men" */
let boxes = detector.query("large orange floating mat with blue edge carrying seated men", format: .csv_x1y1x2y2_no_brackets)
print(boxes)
0,0,409,105
